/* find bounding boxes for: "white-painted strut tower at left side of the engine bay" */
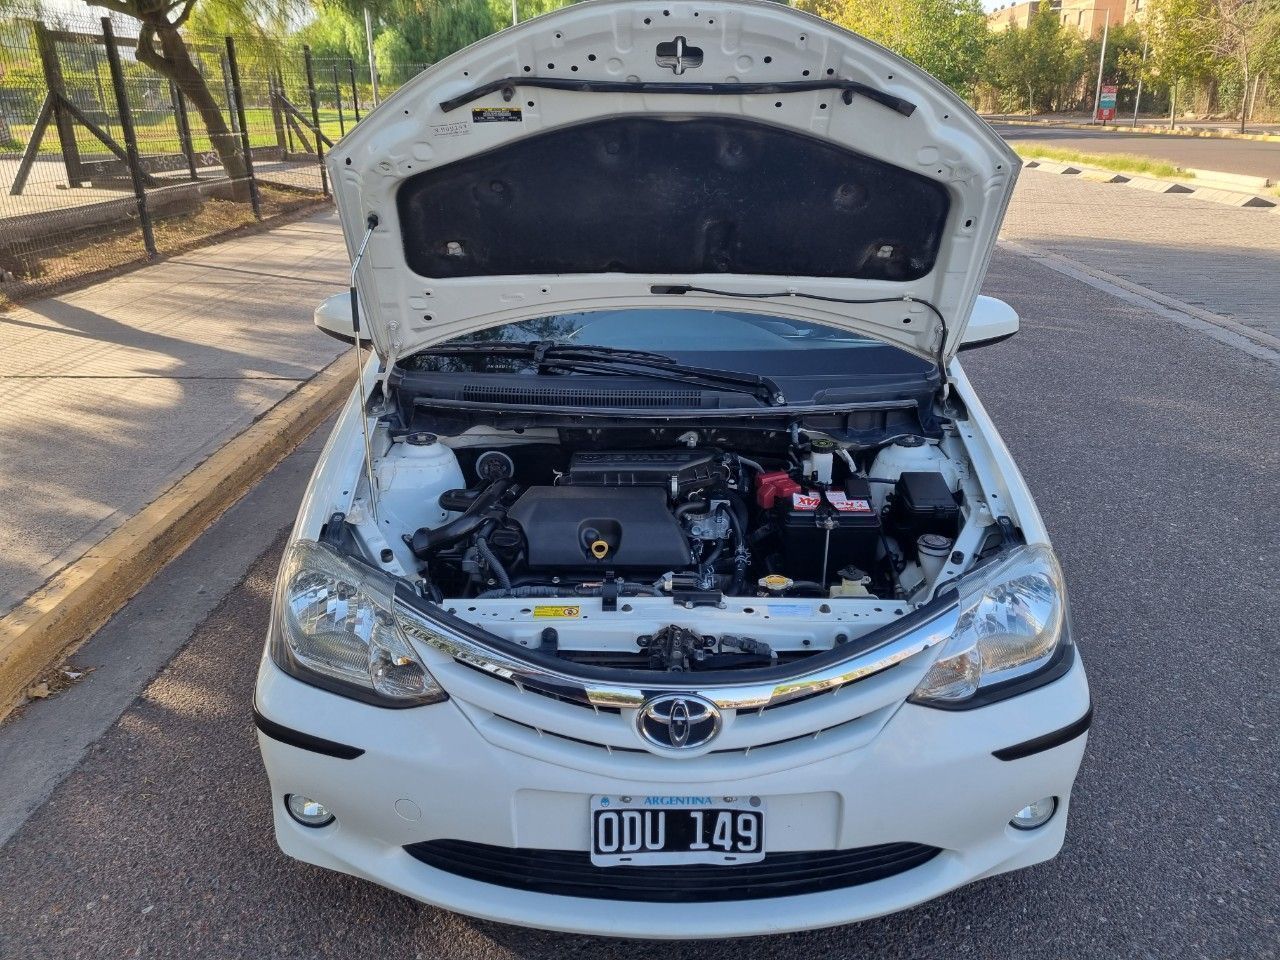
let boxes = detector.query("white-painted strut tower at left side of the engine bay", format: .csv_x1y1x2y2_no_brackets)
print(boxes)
376,433,467,531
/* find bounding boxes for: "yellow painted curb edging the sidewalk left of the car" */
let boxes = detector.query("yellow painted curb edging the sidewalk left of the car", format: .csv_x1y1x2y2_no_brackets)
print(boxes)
0,356,352,719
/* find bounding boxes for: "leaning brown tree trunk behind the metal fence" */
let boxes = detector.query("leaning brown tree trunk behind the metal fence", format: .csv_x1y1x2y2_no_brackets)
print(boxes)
86,0,296,200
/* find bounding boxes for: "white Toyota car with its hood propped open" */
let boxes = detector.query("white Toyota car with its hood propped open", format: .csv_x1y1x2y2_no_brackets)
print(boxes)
255,0,1091,938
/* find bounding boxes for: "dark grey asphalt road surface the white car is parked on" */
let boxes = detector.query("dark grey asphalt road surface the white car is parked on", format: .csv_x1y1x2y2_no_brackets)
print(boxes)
0,251,1280,960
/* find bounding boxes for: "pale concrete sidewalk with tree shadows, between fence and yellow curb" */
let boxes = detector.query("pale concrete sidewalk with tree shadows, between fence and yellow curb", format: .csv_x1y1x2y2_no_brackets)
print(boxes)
0,212,347,616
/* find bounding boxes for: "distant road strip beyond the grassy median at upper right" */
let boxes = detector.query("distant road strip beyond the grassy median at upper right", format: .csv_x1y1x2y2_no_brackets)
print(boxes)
992,123,1280,182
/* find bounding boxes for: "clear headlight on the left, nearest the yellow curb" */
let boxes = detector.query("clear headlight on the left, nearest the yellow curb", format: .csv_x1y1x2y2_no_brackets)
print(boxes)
271,540,447,707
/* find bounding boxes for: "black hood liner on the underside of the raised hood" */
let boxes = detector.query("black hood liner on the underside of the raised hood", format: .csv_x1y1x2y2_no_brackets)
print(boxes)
397,116,950,280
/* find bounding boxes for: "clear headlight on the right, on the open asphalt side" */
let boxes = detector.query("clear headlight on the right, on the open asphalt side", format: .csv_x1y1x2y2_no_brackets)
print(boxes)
911,544,1066,704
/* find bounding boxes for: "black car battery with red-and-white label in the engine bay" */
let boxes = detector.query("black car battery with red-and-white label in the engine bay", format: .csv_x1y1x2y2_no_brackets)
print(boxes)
773,476,881,581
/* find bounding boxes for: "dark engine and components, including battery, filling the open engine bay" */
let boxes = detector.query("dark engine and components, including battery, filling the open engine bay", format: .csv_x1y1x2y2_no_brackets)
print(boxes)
404,438,960,603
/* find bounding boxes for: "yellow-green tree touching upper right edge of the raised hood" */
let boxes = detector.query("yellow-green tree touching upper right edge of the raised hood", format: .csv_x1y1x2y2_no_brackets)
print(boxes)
795,0,989,93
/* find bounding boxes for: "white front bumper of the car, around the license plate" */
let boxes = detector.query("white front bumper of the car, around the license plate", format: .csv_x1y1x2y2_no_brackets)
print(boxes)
256,657,1089,938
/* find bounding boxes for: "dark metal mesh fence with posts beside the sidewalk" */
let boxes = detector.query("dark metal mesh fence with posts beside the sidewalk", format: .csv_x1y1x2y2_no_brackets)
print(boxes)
0,18,421,308
